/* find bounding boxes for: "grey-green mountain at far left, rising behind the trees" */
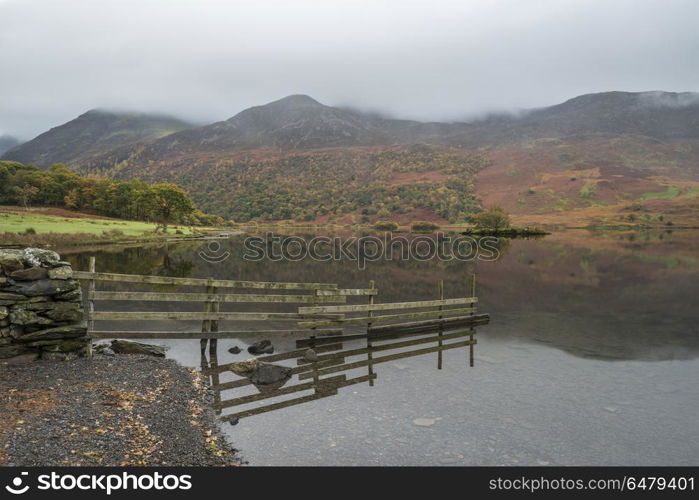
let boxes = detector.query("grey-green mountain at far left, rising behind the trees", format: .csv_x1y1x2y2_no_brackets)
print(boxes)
2,109,193,168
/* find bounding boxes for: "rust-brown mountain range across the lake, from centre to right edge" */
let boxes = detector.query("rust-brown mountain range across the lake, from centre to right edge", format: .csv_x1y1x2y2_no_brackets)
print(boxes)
6,92,699,224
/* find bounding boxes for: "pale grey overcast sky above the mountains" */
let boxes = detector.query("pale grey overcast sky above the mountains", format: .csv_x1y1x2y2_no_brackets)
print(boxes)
0,0,699,139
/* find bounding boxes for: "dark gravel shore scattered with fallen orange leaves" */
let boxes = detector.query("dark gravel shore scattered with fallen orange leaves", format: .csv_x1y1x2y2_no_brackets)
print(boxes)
0,355,240,466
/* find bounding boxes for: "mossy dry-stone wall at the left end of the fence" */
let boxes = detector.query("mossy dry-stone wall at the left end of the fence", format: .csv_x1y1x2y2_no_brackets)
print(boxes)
0,248,89,361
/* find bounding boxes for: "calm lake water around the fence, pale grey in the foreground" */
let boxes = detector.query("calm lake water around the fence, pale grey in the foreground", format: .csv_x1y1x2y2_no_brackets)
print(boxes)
63,230,699,465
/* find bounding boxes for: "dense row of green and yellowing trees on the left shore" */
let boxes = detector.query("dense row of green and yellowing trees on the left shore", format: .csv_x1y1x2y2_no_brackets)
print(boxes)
0,161,222,229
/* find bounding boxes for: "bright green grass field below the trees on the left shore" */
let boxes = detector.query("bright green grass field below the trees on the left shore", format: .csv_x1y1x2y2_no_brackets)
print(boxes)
0,209,192,236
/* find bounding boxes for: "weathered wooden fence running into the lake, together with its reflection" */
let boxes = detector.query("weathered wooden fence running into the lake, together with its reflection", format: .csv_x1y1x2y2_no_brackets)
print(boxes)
73,258,489,419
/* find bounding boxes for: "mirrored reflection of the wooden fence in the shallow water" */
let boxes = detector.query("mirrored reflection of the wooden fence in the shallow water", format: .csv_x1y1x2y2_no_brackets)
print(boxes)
201,327,477,423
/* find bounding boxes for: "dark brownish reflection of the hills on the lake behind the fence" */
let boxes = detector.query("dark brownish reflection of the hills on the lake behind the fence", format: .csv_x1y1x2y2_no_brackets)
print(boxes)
65,231,699,361
